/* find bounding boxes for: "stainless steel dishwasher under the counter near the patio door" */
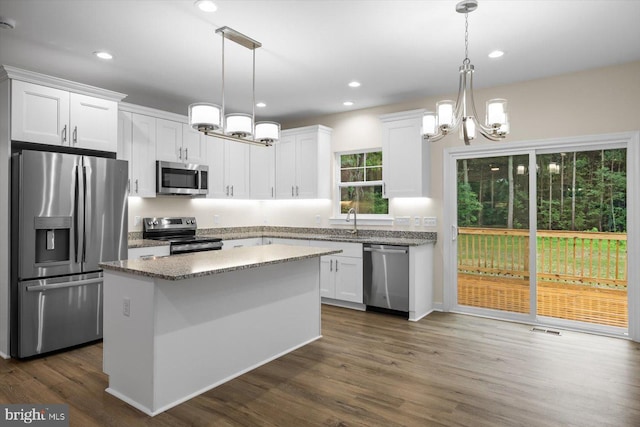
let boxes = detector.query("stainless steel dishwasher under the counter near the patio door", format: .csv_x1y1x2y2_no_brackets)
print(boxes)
363,244,409,315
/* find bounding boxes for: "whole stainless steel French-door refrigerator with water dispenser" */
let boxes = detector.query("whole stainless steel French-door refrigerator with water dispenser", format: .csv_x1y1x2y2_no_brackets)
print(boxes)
11,150,128,358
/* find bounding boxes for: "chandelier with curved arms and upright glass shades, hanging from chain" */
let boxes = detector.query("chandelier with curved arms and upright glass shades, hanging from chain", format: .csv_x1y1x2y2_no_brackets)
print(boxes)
422,0,509,145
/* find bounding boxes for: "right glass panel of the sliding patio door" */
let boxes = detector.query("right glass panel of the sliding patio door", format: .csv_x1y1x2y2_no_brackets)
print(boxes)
536,149,628,328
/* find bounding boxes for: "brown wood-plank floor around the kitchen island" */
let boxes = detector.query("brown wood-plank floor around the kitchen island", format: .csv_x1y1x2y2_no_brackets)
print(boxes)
0,306,640,427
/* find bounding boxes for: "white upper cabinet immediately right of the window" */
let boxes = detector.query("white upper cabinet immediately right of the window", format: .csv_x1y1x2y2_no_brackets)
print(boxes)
380,110,430,197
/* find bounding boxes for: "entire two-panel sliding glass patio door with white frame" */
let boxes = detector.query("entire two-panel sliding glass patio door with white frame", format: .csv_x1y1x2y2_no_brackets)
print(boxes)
445,135,630,334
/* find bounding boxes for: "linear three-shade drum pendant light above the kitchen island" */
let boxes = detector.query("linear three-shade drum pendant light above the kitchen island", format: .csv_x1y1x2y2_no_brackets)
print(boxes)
189,27,280,146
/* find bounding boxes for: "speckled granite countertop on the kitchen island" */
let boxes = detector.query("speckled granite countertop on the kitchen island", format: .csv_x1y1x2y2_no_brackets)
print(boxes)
100,245,342,280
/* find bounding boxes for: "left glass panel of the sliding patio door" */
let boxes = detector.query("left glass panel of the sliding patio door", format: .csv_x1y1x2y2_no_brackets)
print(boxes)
457,155,531,313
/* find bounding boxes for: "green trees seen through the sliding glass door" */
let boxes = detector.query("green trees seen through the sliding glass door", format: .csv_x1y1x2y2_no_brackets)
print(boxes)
458,149,627,232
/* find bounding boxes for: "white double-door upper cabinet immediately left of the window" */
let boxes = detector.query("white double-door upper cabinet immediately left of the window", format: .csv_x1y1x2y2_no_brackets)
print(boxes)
274,126,331,199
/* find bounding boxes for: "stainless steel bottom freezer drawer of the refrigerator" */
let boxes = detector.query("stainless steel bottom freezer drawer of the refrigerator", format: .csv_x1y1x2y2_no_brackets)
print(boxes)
17,272,103,357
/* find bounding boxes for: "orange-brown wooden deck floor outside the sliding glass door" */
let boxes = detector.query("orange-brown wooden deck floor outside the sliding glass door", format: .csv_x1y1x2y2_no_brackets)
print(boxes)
458,274,628,328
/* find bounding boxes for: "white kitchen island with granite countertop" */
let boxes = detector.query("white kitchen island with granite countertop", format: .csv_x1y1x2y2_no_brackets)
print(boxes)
101,245,340,416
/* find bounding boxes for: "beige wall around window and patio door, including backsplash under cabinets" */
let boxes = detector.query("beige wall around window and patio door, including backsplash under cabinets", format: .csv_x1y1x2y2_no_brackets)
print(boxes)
129,61,640,303
